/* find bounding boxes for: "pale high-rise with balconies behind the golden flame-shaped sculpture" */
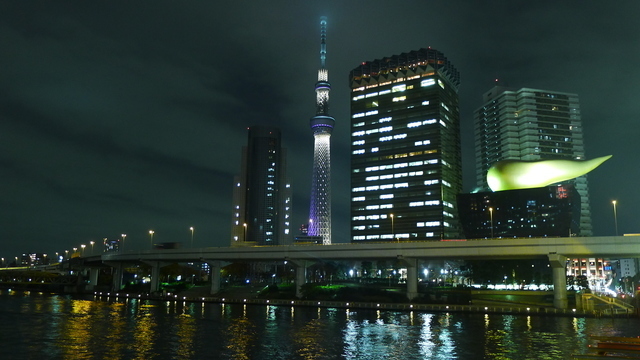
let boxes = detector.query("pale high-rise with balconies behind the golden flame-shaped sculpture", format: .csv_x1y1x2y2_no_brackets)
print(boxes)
475,86,592,236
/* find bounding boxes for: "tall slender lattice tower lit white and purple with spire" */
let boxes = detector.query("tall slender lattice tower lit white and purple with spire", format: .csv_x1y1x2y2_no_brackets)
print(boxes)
309,16,336,245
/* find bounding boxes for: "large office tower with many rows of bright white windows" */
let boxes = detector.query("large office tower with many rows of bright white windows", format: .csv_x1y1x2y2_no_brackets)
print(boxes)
349,48,462,242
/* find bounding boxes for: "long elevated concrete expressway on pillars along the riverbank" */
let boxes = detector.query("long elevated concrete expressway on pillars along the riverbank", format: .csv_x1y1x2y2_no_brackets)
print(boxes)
96,236,640,308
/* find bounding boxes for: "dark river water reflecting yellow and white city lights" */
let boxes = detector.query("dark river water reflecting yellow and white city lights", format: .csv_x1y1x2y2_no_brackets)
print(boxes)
0,290,640,360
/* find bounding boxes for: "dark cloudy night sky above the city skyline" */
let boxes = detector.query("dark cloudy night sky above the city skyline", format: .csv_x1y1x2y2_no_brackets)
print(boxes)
0,0,640,258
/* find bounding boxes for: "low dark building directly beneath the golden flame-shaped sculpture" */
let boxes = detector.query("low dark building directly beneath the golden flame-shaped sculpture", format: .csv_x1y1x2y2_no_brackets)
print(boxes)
458,185,580,239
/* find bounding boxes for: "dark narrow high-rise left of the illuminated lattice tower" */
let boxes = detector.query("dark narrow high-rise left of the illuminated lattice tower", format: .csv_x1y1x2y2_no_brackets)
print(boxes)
231,126,291,246
